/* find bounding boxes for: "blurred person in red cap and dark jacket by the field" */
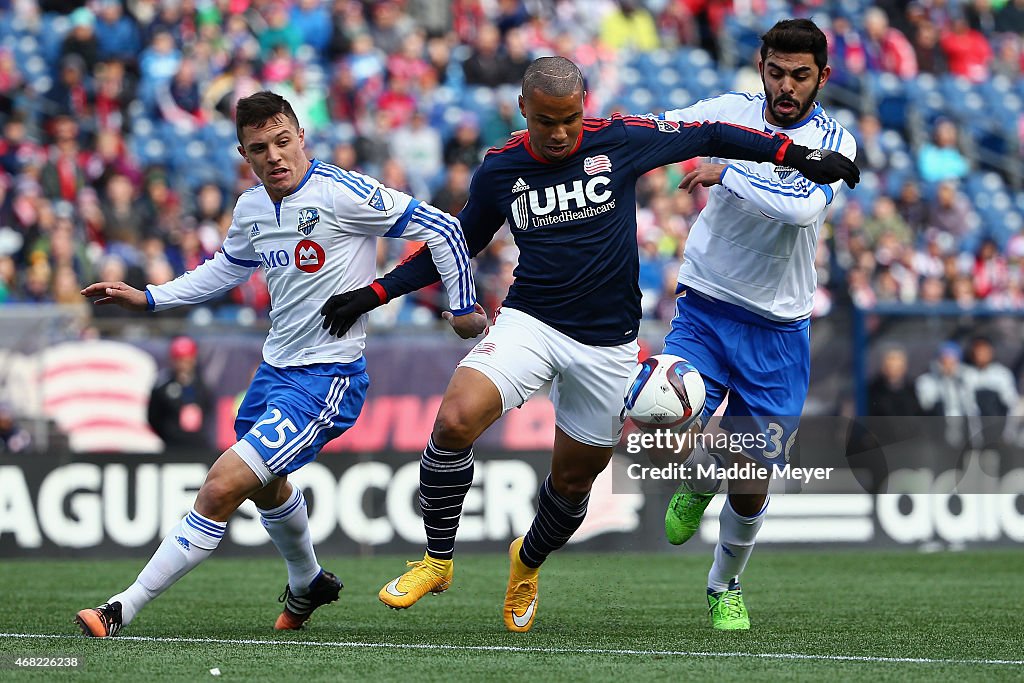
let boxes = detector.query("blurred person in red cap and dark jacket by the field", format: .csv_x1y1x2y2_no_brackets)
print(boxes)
147,337,214,450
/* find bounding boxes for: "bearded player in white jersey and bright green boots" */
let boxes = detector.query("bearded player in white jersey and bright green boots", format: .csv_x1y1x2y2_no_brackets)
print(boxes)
662,19,856,630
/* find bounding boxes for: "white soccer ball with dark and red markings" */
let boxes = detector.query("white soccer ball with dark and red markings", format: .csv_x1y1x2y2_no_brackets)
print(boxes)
623,353,707,431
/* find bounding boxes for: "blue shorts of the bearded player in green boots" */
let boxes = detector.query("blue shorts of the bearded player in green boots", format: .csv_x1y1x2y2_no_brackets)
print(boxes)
665,290,811,465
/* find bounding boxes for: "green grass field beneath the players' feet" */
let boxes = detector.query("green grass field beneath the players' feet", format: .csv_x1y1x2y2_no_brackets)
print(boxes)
0,550,1024,682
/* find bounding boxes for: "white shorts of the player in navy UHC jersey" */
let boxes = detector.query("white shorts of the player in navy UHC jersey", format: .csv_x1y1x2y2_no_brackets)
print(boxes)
459,308,640,446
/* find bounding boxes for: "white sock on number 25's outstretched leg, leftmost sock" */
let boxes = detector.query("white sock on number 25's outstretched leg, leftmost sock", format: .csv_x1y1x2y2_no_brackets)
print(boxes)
108,508,227,626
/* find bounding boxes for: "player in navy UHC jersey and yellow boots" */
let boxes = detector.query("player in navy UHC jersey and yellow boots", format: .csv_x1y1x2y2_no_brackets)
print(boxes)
323,57,858,632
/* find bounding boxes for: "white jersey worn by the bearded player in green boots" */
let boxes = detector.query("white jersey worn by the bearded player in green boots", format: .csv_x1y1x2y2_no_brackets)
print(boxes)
662,92,857,322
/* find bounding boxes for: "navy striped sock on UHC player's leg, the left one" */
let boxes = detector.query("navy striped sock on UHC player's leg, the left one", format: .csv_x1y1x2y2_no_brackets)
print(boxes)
420,439,473,560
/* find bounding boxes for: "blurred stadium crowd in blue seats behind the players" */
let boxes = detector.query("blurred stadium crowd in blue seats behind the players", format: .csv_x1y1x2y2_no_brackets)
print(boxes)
0,0,1024,322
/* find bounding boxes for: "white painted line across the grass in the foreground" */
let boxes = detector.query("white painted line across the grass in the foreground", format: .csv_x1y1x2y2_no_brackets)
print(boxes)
0,633,1024,667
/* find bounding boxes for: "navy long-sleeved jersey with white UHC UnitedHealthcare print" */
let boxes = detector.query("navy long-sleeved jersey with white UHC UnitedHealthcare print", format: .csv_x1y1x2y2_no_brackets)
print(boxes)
380,115,790,346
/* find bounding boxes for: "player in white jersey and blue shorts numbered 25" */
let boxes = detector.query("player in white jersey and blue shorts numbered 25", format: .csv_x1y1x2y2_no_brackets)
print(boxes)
76,91,486,637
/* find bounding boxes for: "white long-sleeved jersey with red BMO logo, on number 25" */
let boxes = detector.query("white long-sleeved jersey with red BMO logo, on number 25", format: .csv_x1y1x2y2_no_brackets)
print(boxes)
146,159,476,368
